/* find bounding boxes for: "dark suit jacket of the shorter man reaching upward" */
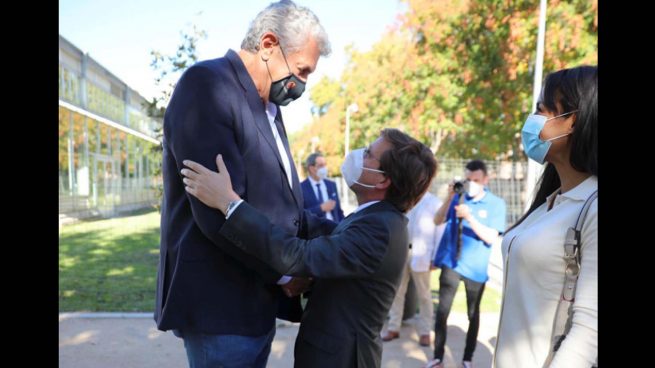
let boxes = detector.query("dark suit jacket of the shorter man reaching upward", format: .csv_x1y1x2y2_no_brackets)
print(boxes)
219,201,409,368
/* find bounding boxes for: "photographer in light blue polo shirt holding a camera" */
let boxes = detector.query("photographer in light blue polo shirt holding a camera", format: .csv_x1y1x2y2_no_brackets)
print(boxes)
426,160,506,368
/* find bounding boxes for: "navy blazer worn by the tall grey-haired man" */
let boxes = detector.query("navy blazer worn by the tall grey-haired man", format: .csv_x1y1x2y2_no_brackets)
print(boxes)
154,50,333,336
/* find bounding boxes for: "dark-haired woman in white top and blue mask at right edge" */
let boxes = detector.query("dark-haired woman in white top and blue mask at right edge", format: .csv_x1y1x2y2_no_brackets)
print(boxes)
494,66,598,368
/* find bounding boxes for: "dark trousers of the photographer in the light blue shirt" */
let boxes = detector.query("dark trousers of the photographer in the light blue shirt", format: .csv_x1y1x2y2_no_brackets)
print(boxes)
434,267,485,361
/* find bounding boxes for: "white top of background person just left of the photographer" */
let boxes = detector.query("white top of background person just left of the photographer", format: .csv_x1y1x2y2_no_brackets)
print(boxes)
407,192,446,272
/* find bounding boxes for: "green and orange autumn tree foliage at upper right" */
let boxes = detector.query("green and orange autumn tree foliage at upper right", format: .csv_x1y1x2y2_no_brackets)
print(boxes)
294,0,598,160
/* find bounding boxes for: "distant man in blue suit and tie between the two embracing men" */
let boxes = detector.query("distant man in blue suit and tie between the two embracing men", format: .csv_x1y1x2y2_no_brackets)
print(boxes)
300,152,343,223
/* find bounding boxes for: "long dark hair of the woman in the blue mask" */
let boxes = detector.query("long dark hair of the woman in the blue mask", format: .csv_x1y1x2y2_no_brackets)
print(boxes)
507,66,598,231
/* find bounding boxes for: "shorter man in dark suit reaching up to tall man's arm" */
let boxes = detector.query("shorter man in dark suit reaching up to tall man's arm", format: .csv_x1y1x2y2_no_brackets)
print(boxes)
181,129,436,368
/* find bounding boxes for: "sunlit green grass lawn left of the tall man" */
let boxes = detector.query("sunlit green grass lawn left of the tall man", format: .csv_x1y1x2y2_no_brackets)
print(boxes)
59,211,159,312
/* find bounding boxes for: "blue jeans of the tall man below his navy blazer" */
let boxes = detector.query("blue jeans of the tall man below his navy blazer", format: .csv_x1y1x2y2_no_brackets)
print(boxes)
174,327,275,368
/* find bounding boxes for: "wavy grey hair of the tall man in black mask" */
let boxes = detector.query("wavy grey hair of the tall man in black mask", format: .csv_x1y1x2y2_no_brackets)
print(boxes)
241,0,332,56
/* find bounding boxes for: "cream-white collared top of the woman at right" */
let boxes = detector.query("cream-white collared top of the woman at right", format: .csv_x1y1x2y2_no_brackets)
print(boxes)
494,176,598,368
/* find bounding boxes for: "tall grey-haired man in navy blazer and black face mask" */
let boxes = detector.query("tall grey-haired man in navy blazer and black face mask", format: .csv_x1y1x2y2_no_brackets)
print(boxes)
154,0,335,367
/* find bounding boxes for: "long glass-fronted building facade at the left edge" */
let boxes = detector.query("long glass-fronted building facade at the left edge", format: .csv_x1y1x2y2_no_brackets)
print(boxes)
59,35,161,221
